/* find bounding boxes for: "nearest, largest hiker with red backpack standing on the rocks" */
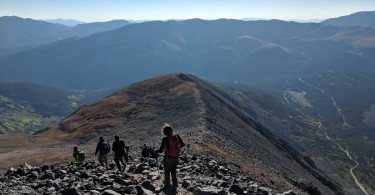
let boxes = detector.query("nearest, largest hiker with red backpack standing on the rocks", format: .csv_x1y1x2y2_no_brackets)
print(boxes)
156,124,185,191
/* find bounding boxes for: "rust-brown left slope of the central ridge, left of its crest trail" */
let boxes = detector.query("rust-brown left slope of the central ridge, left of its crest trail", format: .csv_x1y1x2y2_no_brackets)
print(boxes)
0,75,203,172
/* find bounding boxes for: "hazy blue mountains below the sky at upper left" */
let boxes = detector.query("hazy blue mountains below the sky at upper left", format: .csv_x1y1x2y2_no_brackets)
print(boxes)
0,16,130,56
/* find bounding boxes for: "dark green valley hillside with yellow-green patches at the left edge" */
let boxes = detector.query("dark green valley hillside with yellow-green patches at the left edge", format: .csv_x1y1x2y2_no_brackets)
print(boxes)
0,83,105,133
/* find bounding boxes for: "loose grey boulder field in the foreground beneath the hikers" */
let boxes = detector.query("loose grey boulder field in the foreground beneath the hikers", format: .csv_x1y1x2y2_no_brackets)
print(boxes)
0,147,300,195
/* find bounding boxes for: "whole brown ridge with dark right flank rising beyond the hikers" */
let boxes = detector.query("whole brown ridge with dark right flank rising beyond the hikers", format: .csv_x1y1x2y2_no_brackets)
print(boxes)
0,74,343,194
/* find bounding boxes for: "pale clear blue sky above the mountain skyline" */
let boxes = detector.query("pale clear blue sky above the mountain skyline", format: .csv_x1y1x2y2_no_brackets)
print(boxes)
0,0,375,22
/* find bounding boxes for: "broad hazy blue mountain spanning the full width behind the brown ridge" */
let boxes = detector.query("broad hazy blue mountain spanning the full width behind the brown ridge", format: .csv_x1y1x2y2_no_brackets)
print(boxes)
0,20,375,89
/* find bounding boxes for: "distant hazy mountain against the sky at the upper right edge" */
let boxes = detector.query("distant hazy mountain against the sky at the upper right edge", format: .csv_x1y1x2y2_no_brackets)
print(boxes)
321,11,375,28
